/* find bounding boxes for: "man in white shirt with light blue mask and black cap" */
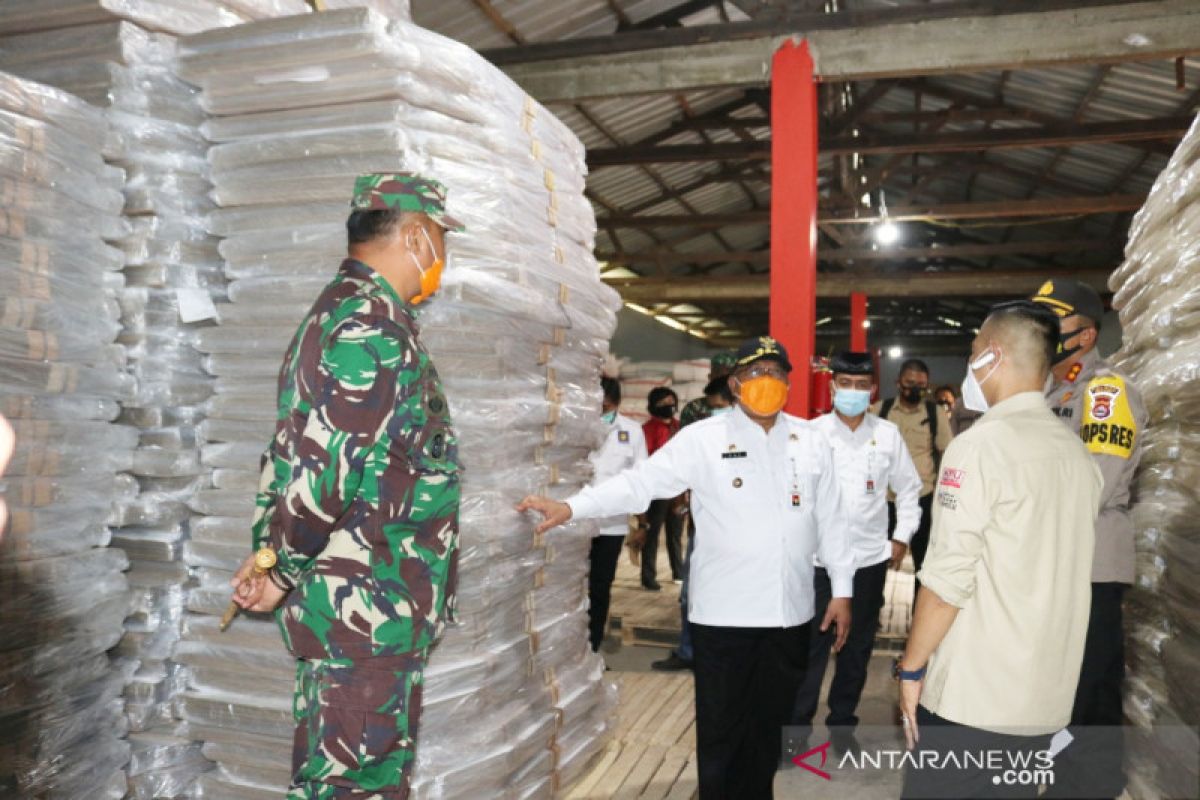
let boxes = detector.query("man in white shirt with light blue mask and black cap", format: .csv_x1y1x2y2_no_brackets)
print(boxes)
792,353,922,752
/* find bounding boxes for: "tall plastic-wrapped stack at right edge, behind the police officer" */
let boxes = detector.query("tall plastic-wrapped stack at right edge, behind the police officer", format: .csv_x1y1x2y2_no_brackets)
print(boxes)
1109,113,1200,800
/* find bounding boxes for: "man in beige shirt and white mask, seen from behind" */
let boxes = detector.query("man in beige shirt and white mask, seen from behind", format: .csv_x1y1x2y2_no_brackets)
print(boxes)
896,301,1103,798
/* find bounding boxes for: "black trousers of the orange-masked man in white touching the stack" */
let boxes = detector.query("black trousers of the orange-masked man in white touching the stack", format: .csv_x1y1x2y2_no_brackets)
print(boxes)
691,622,811,800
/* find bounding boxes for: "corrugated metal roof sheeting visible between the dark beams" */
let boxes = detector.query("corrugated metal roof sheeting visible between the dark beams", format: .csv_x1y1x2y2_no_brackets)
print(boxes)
413,0,1200,340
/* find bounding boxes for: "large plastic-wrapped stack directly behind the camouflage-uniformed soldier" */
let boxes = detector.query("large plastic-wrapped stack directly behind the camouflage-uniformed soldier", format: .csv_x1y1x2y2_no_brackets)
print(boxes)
178,10,619,799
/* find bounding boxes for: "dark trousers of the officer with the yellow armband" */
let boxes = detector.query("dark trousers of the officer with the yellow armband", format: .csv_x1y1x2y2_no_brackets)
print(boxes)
1044,583,1126,798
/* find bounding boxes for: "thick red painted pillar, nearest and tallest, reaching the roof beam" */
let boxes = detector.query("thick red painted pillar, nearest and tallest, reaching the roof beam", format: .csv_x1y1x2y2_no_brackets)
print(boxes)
770,41,818,417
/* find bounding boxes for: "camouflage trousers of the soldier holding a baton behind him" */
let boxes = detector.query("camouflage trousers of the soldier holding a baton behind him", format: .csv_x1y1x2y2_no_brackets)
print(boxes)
288,658,424,800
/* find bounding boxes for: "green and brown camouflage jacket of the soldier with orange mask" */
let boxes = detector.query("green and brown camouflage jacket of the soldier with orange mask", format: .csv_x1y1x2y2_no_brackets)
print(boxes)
253,259,461,663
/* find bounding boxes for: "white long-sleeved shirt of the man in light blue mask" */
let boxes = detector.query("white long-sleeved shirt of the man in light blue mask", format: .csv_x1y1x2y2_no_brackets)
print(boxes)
814,413,923,569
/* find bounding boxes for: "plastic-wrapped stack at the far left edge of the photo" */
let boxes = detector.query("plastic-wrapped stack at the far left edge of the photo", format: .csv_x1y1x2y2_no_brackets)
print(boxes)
0,74,137,800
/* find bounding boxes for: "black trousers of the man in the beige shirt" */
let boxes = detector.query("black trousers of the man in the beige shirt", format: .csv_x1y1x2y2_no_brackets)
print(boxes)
900,705,1051,800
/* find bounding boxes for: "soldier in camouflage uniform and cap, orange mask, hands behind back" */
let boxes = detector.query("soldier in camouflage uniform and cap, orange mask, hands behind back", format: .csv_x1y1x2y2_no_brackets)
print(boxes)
232,174,462,800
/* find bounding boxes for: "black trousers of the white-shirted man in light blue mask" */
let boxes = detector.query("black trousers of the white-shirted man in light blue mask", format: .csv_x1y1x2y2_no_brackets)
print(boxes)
792,561,889,727
